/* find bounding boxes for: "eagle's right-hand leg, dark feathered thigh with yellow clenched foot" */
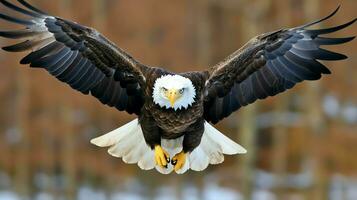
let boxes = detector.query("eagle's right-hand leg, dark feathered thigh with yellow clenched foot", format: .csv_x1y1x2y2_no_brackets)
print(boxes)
171,121,204,171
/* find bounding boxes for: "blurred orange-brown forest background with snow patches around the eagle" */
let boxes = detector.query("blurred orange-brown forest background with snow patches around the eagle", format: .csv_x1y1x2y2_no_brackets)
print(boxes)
0,0,357,200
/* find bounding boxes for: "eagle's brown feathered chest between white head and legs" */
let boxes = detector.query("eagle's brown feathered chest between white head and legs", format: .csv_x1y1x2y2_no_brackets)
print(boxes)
151,103,203,138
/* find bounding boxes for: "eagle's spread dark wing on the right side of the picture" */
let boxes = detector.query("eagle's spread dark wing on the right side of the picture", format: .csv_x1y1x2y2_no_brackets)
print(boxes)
204,8,357,123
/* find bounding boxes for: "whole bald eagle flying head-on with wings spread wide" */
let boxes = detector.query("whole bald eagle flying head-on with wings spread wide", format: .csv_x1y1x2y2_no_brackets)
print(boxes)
0,0,356,174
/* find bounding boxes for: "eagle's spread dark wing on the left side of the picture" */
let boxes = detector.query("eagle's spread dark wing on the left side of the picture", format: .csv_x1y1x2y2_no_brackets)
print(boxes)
0,0,147,114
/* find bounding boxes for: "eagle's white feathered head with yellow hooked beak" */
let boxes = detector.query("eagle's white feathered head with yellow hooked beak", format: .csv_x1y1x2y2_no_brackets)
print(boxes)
152,75,196,110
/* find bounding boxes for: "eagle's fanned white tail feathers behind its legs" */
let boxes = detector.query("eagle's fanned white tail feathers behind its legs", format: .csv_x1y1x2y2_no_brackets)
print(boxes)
91,119,247,174
